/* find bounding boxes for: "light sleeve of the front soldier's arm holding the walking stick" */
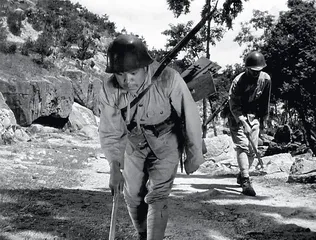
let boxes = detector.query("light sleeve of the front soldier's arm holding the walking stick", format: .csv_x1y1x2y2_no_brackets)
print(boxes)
99,81,127,168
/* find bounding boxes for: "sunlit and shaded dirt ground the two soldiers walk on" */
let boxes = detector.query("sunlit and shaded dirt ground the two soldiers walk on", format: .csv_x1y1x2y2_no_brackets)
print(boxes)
0,132,316,240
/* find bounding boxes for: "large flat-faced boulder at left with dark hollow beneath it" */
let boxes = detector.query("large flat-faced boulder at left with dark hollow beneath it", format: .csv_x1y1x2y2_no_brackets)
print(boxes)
0,74,74,126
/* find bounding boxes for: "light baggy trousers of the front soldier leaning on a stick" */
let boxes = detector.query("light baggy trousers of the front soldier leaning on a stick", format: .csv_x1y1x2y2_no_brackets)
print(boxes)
123,144,180,240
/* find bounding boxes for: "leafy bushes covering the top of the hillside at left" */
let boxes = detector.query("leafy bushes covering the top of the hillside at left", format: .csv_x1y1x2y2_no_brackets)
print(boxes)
0,0,117,66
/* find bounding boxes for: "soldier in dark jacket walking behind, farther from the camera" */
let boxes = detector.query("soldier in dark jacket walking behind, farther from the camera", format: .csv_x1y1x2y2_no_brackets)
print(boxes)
228,51,271,196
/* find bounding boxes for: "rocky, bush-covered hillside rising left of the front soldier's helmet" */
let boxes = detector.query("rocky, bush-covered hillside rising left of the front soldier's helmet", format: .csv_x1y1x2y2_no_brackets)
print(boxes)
0,0,116,133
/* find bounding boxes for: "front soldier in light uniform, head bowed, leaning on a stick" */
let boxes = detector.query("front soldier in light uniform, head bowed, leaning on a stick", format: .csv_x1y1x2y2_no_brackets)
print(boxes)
99,35,204,240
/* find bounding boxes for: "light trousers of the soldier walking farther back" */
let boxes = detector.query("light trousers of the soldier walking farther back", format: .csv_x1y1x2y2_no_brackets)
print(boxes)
229,119,260,177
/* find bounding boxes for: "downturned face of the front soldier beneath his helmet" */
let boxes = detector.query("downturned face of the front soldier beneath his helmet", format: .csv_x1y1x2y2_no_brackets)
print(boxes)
114,68,147,92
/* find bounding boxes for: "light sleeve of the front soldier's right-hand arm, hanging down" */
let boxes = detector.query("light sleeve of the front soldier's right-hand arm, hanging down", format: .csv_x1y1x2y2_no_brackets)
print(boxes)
170,73,204,164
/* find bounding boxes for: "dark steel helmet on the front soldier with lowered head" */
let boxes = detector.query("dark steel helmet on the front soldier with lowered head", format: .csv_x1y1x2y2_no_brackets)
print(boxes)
105,34,153,73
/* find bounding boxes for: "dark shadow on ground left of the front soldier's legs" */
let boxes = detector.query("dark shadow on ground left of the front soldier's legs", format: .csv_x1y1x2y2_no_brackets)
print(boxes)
0,189,134,240
